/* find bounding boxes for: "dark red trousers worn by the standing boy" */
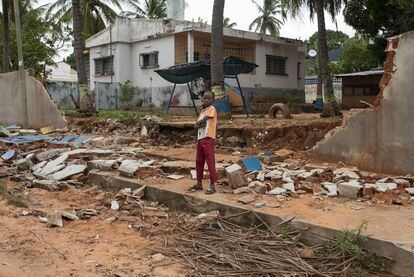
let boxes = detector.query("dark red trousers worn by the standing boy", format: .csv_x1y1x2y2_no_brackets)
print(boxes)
196,138,217,184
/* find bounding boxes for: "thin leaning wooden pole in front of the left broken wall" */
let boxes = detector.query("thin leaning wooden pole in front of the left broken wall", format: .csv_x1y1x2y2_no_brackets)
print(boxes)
13,0,29,128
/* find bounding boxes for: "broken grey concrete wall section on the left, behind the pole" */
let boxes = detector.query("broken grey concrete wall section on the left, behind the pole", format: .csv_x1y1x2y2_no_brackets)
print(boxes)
0,72,67,128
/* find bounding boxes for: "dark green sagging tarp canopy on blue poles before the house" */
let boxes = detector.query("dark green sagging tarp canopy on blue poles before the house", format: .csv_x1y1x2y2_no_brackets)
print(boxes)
155,56,257,84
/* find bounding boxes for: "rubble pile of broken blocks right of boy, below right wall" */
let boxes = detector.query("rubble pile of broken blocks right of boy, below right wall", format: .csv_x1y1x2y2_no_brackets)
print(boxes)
225,149,414,207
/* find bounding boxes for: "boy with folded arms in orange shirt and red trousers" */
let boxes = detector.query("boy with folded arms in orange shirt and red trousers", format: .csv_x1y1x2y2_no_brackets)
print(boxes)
188,91,217,194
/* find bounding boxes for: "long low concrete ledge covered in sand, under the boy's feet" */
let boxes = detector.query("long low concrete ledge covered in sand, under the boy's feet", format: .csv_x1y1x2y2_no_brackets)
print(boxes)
89,170,414,276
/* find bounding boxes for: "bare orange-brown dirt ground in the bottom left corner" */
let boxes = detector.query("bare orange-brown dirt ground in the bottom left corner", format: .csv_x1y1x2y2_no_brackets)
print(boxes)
0,182,186,277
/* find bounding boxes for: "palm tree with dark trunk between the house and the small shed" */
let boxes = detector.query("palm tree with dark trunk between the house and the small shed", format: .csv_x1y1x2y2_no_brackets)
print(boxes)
281,0,347,116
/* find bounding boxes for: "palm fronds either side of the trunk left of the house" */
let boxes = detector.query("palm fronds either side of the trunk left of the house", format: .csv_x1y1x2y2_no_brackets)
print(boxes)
46,0,122,38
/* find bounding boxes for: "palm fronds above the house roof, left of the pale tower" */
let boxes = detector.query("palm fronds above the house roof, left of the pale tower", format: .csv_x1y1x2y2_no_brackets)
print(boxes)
124,0,167,19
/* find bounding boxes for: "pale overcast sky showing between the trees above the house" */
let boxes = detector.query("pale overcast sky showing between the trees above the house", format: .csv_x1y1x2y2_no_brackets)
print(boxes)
39,0,355,59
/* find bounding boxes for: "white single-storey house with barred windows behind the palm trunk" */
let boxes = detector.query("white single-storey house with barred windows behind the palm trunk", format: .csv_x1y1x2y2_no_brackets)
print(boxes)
86,17,305,107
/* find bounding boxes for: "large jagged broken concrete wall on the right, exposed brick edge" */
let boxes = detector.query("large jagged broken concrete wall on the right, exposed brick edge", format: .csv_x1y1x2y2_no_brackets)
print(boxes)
310,31,414,174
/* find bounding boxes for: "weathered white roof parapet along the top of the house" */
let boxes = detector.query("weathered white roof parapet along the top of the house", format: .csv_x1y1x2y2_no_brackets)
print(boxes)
86,17,304,48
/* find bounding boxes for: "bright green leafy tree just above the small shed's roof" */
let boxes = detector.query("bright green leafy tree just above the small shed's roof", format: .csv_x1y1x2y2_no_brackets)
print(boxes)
342,39,377,72
